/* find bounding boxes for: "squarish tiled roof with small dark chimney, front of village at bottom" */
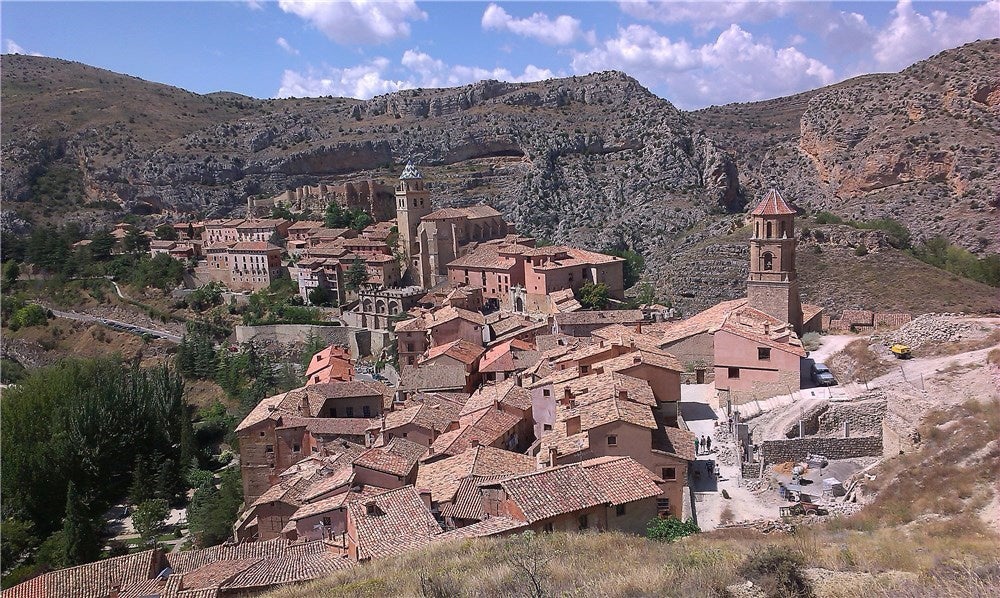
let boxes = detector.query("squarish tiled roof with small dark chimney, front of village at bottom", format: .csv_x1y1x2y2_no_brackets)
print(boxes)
347,486,441,560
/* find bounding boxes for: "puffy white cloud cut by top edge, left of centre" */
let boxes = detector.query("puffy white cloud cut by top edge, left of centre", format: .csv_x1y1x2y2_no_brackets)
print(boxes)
278,0,427,44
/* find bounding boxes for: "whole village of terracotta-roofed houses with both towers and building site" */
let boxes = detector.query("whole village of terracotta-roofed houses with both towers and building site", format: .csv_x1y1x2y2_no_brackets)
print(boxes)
3,164,996,598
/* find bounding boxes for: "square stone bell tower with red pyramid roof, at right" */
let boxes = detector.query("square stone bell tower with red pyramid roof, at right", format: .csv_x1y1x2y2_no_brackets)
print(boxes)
747,189,802,334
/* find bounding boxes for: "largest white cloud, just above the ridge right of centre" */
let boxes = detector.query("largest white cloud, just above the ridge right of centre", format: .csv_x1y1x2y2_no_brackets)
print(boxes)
572,25,835,107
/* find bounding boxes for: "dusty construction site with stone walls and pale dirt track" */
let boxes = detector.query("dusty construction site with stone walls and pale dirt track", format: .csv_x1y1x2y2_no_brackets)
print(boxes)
682,314,1000,532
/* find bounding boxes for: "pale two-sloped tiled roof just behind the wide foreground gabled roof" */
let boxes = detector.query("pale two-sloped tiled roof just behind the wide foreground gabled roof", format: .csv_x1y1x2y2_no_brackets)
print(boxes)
416,445,535,503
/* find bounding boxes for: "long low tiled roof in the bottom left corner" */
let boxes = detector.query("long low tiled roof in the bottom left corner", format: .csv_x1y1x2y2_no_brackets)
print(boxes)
0,550,162,598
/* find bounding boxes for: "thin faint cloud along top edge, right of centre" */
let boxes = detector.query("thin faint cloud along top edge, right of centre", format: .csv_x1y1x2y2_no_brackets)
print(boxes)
618,0,792,33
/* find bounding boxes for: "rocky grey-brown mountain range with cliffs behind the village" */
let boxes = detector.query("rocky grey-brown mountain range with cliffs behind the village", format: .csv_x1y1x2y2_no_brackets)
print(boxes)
0,40,1000,310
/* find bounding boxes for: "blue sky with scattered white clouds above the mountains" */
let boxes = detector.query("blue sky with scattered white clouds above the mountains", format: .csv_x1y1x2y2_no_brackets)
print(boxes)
0,0,1000,109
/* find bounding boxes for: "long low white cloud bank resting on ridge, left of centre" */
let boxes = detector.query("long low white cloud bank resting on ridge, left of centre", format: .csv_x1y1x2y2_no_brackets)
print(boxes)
277,50,556,99
